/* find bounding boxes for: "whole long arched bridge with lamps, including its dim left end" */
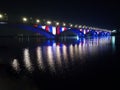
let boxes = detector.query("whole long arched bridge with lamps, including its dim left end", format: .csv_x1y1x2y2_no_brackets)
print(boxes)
0,14,112,39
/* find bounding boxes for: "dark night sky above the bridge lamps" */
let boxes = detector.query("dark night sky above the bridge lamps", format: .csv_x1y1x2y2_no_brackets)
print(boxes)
0,0,120,29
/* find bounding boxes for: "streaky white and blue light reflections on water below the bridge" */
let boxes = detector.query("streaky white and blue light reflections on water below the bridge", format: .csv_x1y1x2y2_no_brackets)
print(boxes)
12,37,115,72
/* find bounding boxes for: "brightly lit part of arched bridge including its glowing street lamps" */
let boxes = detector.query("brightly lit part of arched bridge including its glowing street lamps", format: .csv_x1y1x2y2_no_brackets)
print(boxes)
1,15,112,39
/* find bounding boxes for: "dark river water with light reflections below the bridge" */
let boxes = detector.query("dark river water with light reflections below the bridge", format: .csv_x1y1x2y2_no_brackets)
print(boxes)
0,36,120,90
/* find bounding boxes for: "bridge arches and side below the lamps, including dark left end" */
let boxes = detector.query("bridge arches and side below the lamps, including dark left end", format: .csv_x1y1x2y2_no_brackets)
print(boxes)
0,23,111,39
